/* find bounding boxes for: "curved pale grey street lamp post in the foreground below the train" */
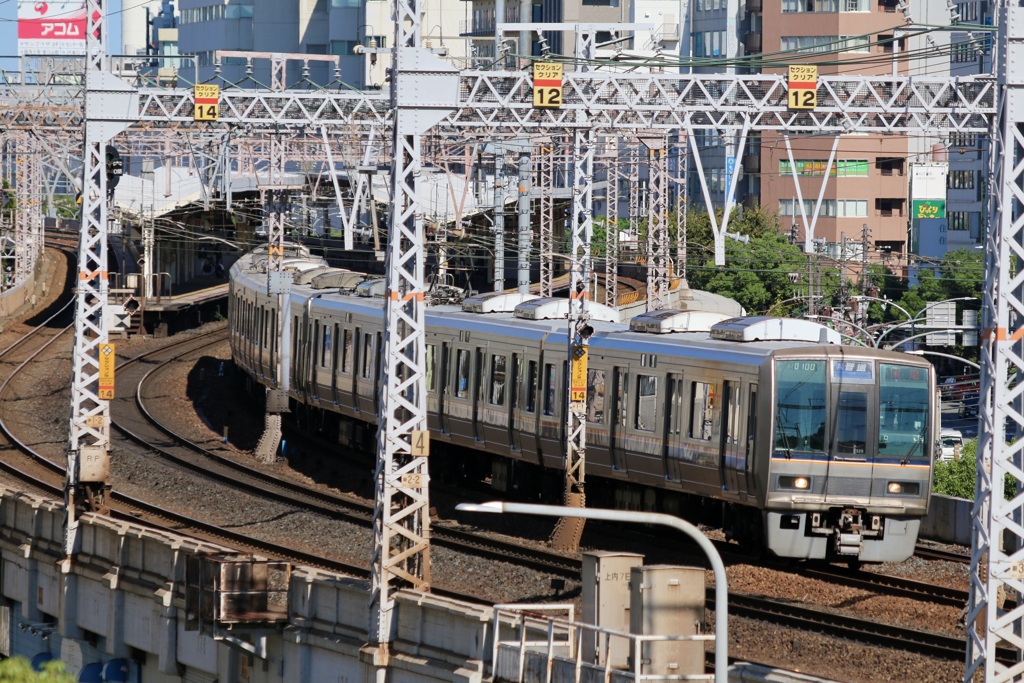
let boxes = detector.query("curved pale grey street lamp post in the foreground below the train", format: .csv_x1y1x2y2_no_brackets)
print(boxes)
455,501,729,683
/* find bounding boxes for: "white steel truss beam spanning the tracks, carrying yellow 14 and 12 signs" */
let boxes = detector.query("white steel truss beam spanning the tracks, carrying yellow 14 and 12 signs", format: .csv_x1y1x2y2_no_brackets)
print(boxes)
0,71,995,134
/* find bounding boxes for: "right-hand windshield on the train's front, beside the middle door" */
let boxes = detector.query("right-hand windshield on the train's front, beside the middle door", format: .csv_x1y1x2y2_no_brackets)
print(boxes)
879,362,929,458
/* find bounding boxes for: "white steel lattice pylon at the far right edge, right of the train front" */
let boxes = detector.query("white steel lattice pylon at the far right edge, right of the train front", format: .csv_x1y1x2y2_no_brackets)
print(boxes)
964,0,1024,683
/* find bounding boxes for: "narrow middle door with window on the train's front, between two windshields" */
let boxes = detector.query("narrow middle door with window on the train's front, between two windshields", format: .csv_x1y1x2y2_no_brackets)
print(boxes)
825,379,879,502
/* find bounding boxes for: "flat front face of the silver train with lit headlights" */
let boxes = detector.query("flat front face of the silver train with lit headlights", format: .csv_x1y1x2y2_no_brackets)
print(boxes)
762,346,938,562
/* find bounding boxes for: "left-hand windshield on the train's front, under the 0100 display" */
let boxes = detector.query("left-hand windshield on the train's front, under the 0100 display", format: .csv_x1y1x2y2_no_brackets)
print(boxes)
775,359,827,453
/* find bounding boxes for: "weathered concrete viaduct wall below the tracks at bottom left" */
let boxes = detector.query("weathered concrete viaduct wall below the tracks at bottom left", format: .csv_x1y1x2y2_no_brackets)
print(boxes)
0,487,843,683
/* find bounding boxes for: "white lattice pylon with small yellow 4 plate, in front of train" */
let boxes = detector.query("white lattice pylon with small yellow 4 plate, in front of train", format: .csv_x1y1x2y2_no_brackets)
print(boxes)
370,0,459,647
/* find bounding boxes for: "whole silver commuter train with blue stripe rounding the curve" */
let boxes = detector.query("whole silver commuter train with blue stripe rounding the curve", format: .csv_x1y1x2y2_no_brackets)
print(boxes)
229,247,938,564
